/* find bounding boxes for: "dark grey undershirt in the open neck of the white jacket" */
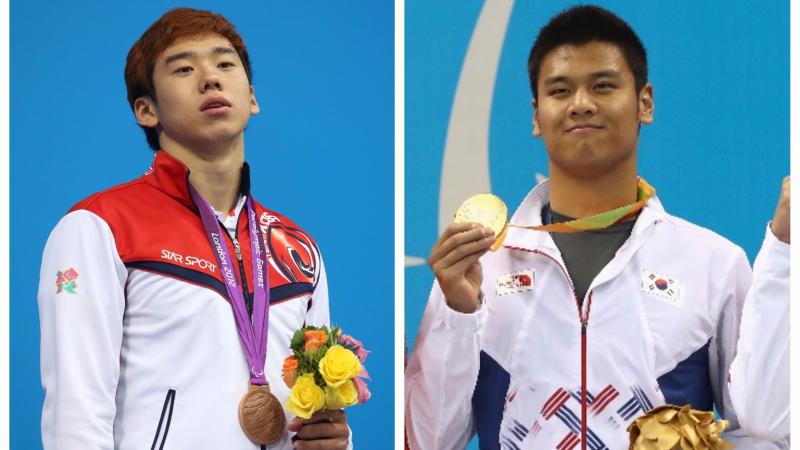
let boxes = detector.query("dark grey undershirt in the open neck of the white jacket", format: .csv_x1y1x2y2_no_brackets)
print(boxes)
542,203,636,304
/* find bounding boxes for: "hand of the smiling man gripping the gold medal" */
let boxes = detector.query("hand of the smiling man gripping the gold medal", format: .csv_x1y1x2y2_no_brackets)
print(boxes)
428,223,495,313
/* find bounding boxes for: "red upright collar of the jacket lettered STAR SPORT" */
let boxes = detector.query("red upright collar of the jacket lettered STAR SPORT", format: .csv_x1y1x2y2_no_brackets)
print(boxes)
142,150,250,211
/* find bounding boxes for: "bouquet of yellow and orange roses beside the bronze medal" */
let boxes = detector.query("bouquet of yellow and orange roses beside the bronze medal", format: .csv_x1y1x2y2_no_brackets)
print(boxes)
283,326,371,419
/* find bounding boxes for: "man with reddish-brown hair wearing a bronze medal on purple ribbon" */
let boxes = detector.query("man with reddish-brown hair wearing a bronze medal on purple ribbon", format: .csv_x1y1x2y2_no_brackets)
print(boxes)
39,8,351,450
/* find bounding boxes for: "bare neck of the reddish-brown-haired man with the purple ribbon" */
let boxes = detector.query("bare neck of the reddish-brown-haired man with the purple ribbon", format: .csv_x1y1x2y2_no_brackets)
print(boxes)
161,135,244,213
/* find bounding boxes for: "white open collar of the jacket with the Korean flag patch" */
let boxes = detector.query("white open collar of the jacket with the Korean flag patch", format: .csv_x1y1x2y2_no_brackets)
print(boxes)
503,180,667,250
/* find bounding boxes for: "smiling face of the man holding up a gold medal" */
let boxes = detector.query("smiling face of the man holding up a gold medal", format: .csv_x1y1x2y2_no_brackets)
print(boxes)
533,42,653,177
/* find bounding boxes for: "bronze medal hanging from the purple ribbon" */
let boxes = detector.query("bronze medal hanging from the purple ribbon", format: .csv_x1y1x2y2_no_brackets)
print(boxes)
239,384,286,445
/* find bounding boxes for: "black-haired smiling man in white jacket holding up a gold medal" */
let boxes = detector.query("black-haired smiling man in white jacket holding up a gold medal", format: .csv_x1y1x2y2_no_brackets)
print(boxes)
406,6,785,450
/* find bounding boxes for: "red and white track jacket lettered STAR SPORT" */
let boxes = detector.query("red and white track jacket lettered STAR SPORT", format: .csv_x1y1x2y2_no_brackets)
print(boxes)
39,151,329,450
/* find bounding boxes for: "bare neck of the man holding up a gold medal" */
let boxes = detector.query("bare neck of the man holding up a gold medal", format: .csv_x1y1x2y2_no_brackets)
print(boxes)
550,162,639,218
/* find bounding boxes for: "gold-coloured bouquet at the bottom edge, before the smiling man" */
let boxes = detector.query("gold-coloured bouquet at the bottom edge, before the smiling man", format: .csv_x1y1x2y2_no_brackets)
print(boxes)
628,405,733,450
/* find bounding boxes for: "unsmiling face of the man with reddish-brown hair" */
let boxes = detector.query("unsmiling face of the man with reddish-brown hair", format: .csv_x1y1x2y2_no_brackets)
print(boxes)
136,34,259,148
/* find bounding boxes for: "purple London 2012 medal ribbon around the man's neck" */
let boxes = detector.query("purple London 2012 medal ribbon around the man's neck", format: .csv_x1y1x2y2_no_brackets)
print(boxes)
189,185,269,385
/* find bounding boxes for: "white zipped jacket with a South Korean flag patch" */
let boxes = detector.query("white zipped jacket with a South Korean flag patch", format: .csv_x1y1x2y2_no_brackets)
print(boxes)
405,182,785,450
